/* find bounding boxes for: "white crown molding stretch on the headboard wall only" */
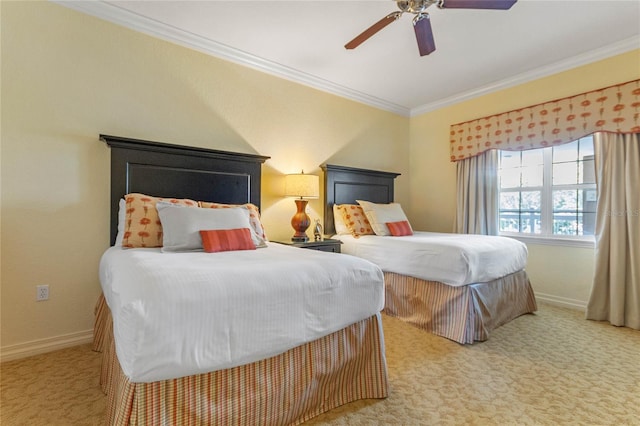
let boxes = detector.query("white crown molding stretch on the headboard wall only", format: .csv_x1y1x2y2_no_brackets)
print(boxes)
50,0,411,117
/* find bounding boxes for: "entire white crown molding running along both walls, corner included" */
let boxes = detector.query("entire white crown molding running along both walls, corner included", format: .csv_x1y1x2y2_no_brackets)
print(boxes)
50,0,640,117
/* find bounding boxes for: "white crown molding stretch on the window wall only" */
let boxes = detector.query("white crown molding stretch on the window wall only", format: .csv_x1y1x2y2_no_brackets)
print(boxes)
410,37,640,117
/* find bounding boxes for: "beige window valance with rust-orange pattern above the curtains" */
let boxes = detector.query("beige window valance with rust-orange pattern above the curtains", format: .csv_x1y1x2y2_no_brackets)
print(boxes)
450,80,640,161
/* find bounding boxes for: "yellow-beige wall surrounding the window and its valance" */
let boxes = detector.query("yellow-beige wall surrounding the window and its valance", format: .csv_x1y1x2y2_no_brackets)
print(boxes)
410,50,640,307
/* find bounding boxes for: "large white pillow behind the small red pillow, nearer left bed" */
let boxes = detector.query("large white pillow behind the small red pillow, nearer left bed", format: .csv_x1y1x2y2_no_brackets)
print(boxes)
156,201,261,251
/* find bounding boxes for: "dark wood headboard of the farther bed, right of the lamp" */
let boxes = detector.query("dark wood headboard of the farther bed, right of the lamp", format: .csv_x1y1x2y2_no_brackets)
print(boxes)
320,164,400,235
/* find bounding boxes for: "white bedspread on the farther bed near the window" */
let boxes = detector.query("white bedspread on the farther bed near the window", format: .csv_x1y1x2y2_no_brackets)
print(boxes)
332,231,527,286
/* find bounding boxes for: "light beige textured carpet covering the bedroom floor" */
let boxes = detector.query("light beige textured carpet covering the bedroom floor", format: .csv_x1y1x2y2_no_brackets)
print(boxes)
0,304,640,426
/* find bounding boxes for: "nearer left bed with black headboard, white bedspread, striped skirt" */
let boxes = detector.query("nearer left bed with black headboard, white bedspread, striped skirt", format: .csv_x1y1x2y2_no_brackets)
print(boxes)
93,135,388,425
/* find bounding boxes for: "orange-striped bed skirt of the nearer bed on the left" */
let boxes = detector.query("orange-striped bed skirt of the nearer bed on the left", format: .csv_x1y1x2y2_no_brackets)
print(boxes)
94,296,389,426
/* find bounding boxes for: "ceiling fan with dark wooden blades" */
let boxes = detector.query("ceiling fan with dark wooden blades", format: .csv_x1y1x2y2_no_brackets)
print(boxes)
344,0,517,56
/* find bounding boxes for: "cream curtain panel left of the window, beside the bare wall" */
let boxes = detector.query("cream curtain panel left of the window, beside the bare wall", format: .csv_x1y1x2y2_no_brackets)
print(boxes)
454,149,499,235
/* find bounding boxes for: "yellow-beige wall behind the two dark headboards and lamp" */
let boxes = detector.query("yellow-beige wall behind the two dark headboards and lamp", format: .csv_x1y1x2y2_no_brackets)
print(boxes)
1,2,409,355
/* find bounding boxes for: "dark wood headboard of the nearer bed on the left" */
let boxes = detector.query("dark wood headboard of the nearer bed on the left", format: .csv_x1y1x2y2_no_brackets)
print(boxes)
100,135,269,244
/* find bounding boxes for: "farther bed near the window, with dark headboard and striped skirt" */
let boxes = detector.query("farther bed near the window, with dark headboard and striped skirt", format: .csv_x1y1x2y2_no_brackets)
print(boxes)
322,164,537,344
